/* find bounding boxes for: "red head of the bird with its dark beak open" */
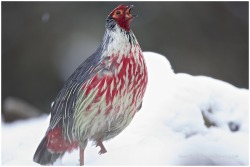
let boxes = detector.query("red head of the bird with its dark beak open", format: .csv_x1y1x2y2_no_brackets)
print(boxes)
107,4,137,31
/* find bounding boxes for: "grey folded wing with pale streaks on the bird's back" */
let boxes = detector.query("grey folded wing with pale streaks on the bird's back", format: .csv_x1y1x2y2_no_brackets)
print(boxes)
48,47,101,137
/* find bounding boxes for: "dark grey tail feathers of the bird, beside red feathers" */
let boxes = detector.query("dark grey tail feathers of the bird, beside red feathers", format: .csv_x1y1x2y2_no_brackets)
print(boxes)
33,136,64,165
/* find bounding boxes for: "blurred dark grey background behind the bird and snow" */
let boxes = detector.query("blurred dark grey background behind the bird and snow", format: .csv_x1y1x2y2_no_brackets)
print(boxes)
2,1,249,121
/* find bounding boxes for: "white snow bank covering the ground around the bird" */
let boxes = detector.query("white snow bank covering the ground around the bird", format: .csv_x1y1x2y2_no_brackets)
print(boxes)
1,52,249,165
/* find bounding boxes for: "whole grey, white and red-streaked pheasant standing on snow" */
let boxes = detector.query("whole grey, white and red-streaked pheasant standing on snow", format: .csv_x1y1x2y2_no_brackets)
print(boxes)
33,4,148,166
